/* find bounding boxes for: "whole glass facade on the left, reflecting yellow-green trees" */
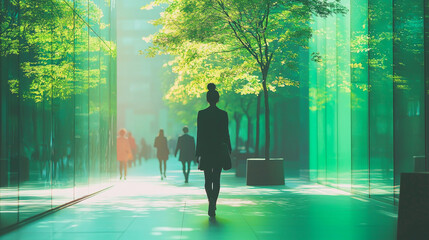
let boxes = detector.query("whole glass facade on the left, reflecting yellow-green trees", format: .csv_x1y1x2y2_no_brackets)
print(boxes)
0,0,117,228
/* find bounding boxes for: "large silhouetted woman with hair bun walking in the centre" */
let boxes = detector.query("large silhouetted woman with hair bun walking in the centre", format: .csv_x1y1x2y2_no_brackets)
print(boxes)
196,83,231,217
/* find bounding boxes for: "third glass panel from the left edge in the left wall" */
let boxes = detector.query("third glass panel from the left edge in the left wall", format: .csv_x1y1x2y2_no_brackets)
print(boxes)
51,2,75,207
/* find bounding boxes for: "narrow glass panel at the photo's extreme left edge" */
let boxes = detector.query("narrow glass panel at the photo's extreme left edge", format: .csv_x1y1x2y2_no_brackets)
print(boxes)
0,1,20,228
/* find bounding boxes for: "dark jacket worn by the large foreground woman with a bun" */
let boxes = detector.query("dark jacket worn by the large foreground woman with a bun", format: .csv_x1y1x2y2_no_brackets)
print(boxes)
196,106,231,170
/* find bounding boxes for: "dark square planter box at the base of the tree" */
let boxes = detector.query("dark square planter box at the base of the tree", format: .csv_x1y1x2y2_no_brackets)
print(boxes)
246,158,285,186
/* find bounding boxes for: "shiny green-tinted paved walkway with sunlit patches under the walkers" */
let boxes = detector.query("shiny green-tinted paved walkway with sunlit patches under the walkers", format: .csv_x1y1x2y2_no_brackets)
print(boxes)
0,159,397,240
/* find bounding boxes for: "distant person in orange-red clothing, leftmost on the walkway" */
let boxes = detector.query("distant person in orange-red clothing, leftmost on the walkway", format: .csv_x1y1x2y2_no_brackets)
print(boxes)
116,128,133,180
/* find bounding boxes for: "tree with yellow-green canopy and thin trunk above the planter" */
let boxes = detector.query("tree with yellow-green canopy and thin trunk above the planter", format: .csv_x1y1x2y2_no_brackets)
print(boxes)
142,0,346,158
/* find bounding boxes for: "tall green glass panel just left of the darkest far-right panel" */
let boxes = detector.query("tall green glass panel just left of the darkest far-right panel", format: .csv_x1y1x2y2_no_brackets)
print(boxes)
368,1,394,201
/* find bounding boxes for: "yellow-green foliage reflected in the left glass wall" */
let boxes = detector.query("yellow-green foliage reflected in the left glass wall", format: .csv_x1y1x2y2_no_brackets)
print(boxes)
0,0,116,102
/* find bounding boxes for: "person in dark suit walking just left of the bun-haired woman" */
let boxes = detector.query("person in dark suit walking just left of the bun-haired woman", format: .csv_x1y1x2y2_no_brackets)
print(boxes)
174,127,195,183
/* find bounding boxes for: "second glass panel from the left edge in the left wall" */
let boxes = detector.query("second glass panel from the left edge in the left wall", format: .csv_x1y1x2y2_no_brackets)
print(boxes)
17,1,53,221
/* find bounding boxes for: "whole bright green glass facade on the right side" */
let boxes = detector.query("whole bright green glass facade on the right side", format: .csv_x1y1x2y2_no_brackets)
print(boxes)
309,0,429,202
